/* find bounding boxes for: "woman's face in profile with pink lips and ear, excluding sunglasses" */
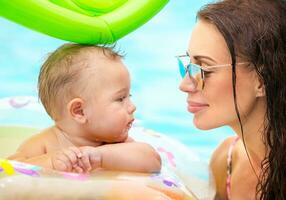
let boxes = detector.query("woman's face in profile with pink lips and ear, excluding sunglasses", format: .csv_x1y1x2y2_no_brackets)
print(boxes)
180,20,257,129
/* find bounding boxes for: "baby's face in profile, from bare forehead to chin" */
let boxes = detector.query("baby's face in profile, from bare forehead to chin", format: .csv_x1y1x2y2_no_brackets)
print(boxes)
79,55,136,143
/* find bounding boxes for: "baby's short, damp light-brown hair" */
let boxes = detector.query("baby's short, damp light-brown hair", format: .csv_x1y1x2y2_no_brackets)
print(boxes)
38,43,123,120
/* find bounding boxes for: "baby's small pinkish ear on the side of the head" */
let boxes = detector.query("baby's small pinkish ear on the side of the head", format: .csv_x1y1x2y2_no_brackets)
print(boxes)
67,98,86,124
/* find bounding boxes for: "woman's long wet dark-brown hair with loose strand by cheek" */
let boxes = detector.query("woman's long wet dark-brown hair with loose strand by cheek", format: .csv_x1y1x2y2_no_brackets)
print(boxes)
198,0,286,200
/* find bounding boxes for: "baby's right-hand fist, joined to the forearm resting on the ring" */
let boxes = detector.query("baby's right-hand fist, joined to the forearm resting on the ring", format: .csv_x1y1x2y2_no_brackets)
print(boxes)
79,146,102,172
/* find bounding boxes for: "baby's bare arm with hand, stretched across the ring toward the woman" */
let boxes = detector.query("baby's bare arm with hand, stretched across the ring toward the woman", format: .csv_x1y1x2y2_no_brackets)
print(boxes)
80,142,161,173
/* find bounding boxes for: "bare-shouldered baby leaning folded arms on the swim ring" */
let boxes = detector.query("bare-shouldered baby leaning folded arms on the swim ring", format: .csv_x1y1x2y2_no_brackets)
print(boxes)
8,44,161,173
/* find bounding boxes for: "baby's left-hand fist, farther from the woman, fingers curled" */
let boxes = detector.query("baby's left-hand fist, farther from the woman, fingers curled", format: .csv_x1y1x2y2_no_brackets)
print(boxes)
51,147,85,173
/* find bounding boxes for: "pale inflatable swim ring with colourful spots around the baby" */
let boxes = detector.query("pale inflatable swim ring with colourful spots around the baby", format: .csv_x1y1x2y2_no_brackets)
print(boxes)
0,97,212,200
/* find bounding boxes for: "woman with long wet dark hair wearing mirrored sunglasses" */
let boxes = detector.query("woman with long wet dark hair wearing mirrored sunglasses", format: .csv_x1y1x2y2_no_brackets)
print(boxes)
178,0,286,200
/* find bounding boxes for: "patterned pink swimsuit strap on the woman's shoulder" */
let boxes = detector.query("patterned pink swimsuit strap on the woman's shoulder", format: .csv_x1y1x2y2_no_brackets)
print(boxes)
226,137,239,200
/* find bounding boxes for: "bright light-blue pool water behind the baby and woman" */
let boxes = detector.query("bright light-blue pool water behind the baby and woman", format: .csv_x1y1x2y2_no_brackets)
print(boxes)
0,0,232,161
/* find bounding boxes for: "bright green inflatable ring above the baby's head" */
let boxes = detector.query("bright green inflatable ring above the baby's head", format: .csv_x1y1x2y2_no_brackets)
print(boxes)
0,0,169,44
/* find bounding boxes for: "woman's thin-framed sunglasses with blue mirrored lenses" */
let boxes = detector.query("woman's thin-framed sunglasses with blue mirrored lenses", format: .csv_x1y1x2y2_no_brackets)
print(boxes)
176,55,246,88
